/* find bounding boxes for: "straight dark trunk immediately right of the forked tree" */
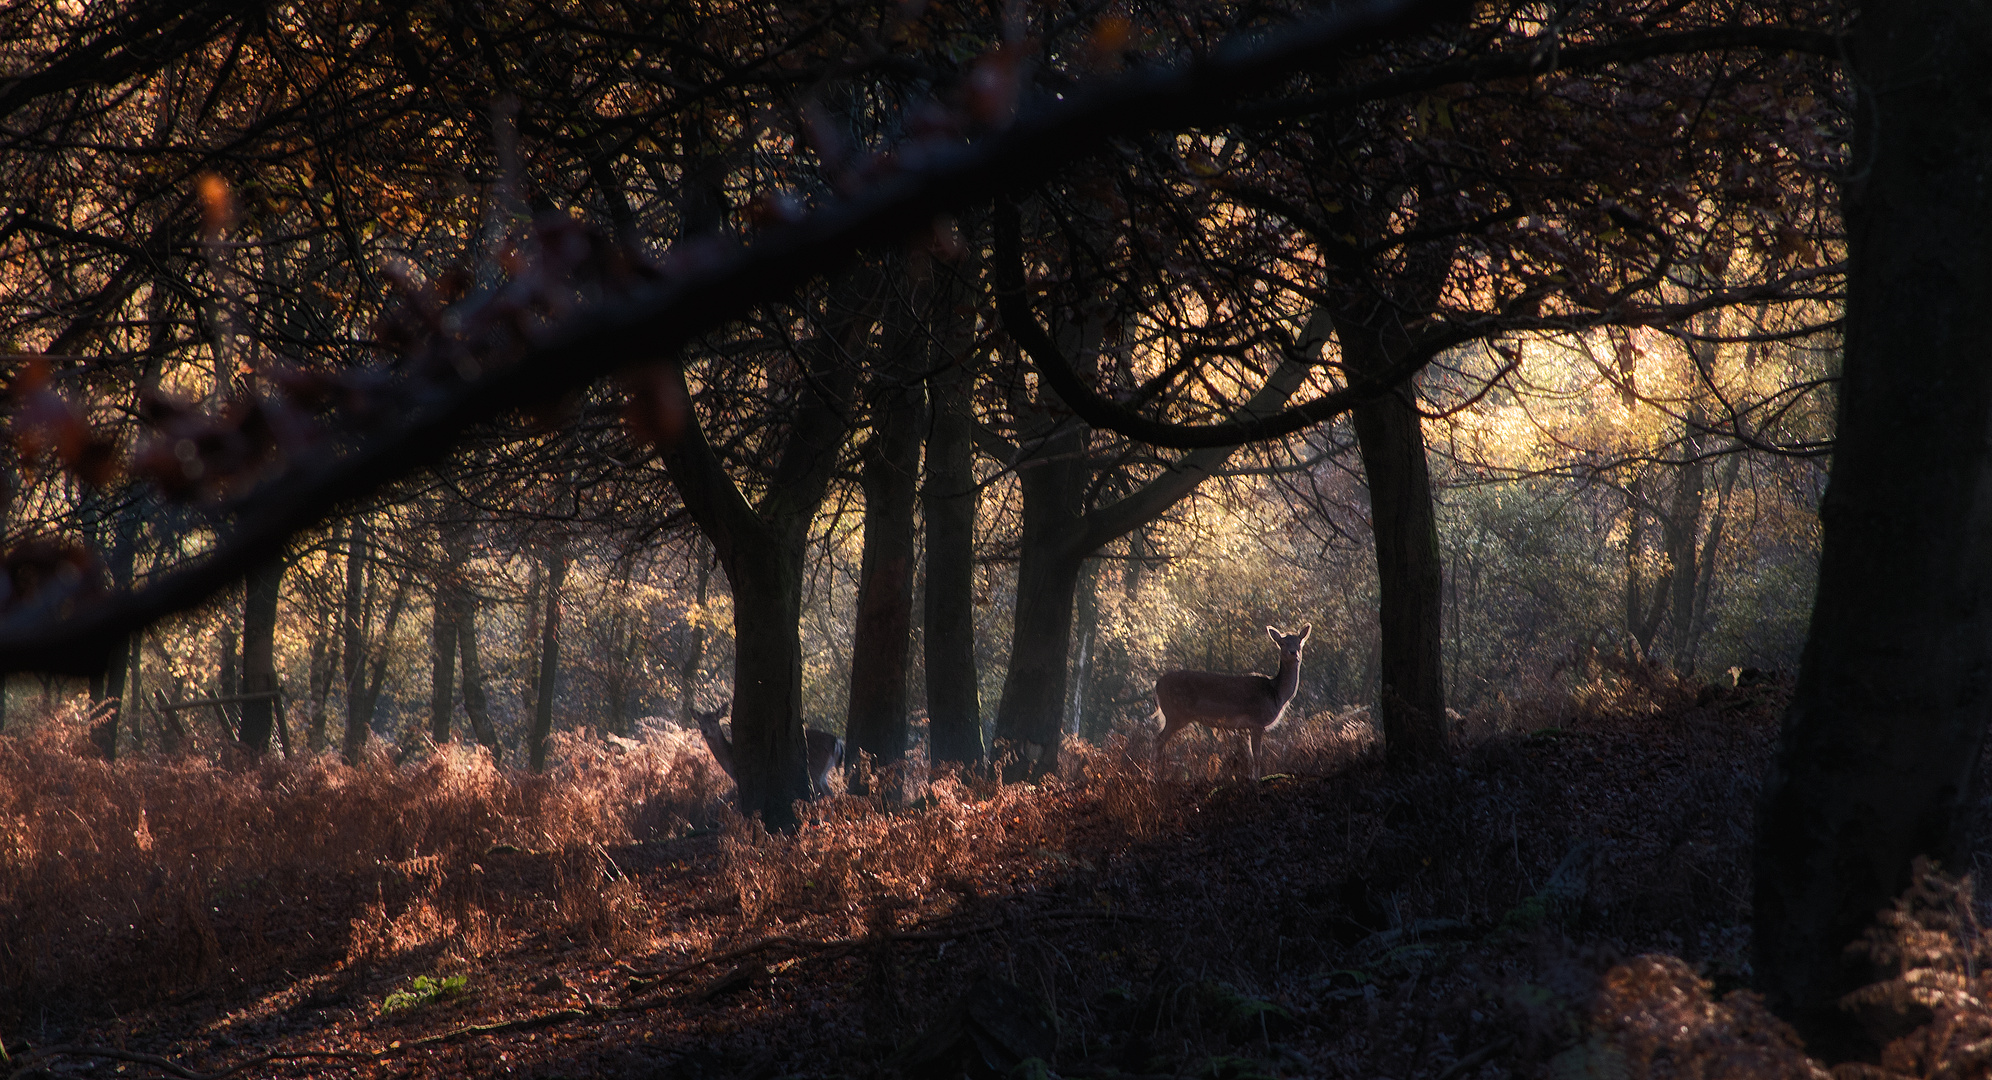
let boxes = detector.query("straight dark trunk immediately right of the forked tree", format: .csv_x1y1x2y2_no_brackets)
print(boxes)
845,376,920,795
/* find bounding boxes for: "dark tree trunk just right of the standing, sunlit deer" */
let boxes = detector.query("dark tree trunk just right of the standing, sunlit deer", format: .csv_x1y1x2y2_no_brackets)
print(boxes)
1337,321,1450,765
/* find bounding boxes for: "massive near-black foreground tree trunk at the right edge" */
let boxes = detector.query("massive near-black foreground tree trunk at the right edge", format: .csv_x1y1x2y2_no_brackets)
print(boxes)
1753,0,1992,1058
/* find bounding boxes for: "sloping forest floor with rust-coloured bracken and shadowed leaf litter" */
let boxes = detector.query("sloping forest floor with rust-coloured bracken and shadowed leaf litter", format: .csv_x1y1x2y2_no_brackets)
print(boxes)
0,679,1984,1080
